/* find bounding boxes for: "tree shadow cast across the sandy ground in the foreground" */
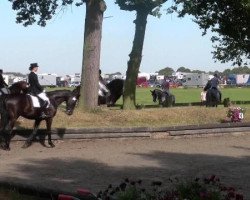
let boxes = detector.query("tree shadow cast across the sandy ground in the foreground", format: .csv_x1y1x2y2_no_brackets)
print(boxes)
0,149,250,199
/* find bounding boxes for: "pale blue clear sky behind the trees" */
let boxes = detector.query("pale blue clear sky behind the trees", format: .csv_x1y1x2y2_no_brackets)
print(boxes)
0,0,232,75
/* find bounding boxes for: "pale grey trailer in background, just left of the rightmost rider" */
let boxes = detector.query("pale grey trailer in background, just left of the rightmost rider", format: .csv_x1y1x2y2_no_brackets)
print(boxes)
182,73,209,87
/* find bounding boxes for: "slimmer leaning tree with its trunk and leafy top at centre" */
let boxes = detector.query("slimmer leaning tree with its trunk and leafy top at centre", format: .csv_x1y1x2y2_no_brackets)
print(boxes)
116,0,167,109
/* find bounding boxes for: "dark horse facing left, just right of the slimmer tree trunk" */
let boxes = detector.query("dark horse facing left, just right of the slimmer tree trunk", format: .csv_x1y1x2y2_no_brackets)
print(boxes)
150,89,175,107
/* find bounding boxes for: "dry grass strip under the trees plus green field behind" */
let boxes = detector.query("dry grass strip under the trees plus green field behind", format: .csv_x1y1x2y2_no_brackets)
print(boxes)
15,88,250,128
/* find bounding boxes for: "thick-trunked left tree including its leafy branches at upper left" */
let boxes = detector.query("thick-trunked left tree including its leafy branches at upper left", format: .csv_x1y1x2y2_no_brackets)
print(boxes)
9,0,106,109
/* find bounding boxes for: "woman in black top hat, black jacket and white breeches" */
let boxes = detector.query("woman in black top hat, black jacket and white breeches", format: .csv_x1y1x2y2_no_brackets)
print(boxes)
28,63,50,118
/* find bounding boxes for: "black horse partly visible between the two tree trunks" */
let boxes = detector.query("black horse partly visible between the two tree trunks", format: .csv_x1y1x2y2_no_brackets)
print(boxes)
98,79,124,106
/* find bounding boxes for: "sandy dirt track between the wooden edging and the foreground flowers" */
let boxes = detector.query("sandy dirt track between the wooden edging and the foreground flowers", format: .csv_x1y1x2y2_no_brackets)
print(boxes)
0,133,250,199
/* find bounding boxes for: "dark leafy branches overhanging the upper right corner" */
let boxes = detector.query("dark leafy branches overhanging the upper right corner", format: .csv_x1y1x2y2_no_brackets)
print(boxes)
171,0,250,65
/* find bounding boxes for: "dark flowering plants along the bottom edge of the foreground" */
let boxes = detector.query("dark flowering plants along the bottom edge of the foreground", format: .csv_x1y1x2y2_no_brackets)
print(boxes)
97,175,243,200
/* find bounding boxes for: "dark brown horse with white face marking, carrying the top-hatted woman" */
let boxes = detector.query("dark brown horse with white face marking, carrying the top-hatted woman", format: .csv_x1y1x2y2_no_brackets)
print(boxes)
0,86,80,150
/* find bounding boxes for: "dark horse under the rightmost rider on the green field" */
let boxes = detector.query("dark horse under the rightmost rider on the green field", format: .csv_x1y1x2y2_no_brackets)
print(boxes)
204,81,221,107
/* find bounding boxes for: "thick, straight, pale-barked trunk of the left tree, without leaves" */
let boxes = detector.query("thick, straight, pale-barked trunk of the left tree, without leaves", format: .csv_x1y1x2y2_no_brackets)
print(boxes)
79,0,106,110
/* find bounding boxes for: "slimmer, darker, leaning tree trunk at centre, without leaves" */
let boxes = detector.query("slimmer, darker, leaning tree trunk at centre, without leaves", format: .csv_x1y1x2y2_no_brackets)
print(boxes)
123,10,148,110
